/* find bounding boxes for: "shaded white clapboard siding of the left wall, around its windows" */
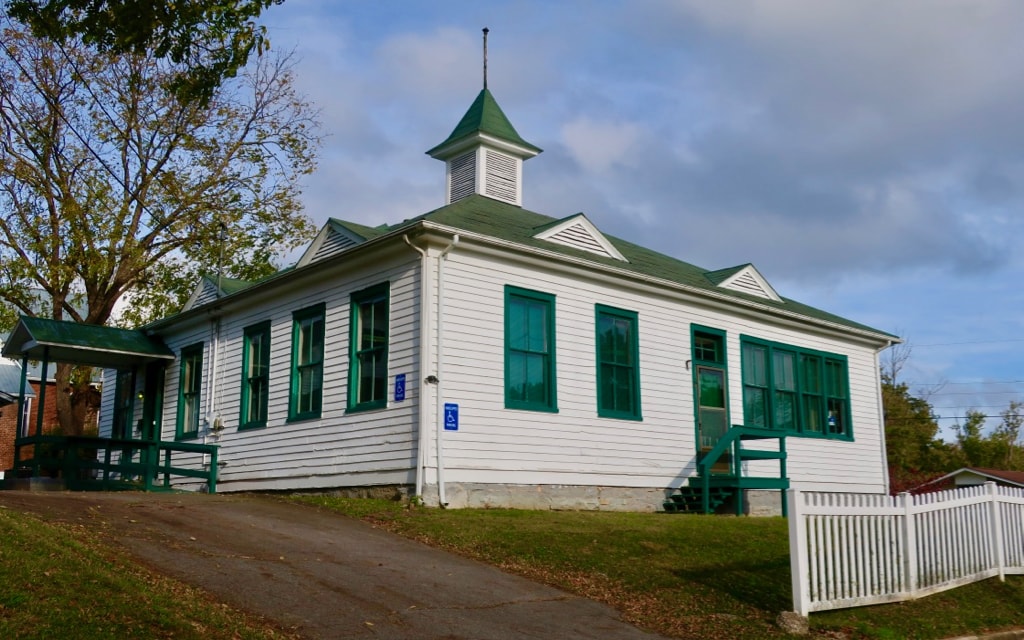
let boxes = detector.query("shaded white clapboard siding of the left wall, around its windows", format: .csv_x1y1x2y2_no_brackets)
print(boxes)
152,252,420,490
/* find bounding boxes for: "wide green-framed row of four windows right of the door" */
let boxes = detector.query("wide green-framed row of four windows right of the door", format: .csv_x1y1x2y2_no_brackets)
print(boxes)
740,336,853,440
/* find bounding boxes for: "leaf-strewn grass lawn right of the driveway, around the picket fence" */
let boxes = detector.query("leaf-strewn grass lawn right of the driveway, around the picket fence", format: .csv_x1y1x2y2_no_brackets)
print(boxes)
294,497,1024,639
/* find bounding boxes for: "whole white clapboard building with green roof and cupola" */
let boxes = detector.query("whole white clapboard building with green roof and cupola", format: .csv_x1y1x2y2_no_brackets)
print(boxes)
100,89,896,511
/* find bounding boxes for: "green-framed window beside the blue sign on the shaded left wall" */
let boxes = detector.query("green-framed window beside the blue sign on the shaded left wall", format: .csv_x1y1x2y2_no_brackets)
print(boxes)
348,283,390,411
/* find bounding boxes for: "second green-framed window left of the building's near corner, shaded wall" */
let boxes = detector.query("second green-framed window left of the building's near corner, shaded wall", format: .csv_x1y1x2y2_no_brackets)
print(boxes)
288,303,327,420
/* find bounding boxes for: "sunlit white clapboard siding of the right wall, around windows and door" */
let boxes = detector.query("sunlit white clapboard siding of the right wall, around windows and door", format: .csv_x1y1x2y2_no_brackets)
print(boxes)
432,249,885,492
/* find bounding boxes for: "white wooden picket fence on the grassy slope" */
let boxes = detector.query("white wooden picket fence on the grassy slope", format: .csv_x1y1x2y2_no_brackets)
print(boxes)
786,482,1024,615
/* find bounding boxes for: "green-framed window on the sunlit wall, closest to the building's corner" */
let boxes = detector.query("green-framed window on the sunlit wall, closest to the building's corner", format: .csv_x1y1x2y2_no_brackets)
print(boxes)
505,286,558,412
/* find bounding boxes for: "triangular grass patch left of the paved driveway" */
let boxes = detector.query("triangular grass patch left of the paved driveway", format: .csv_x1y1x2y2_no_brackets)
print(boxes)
0,509,292,640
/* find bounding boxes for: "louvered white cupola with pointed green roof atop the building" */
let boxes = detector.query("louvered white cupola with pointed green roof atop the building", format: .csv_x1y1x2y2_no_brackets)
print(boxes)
427,87,541,206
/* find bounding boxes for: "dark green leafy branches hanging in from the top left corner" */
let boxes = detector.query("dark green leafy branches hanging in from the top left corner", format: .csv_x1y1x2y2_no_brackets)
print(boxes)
7,0,284,104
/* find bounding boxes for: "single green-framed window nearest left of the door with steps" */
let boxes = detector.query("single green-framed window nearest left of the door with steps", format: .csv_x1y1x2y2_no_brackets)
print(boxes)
594,304,643,420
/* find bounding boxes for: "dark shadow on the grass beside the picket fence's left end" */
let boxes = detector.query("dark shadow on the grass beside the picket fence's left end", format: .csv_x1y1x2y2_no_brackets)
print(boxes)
673,555,793,613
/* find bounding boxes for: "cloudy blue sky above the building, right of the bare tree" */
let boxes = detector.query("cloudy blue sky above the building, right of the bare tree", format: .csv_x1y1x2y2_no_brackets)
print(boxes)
264,0,1024,437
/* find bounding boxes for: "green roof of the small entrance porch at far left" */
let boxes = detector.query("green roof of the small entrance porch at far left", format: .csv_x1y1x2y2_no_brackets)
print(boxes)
3,315,174,369
